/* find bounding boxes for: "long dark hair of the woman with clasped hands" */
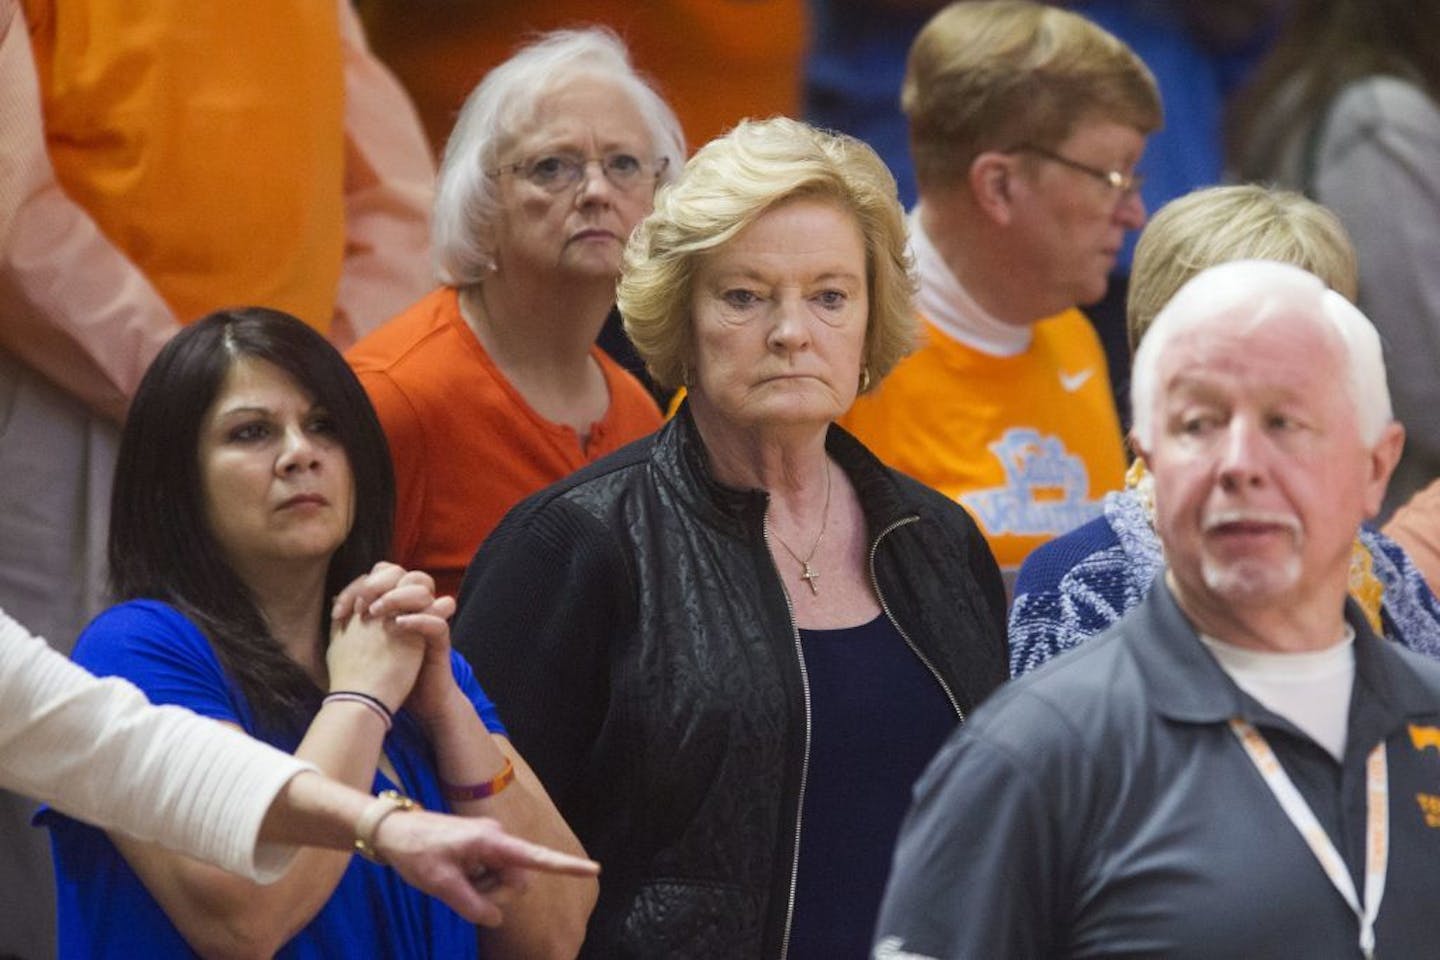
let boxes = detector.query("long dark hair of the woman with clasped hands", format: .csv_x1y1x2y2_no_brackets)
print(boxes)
109,307,395,731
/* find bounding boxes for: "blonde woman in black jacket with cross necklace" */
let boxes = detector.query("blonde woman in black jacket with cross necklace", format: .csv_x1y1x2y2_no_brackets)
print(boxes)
455,119,1005,960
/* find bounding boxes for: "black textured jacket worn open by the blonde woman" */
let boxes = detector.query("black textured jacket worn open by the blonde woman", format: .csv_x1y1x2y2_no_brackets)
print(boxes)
454,409,1007,960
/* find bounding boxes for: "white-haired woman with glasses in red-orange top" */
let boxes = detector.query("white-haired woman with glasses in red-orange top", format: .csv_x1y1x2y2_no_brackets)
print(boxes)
348,27,684,593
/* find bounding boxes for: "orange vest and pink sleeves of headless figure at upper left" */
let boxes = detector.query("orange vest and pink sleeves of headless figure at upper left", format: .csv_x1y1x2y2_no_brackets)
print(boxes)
0,0,435,420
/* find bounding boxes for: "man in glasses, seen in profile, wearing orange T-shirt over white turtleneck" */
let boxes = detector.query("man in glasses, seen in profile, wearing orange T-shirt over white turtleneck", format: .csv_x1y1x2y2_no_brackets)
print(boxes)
841,0,1161,583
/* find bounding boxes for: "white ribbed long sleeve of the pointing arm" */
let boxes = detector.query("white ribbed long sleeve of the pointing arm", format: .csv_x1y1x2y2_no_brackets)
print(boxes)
0,610,314,882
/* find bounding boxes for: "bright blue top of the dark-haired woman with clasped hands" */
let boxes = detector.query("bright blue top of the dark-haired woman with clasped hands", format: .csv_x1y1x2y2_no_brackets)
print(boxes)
37,600,504,960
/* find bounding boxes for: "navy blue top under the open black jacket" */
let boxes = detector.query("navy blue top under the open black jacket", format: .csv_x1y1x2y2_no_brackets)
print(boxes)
789,613,959,960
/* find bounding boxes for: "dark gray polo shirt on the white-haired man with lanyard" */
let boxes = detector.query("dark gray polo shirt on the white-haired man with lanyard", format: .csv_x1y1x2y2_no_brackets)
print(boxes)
876,581,1440,960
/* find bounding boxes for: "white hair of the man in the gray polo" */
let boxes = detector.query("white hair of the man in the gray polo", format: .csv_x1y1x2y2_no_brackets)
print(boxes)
1130,261,1392,449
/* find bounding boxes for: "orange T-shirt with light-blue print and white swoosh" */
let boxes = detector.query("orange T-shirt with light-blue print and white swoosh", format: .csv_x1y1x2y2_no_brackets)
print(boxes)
840,309,1125,579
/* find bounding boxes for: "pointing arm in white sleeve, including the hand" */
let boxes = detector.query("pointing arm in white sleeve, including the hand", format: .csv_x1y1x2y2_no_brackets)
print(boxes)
0,610,598,925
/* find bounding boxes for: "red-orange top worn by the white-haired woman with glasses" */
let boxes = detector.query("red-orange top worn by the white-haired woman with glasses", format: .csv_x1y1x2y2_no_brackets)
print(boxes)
346,286,661,596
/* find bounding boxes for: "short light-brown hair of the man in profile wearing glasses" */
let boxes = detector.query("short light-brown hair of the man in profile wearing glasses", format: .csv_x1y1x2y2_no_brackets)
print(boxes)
900,0,1164,187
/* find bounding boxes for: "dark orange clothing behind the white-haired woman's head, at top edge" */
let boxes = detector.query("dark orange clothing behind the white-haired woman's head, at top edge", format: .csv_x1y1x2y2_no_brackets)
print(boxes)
351,0,800,151
